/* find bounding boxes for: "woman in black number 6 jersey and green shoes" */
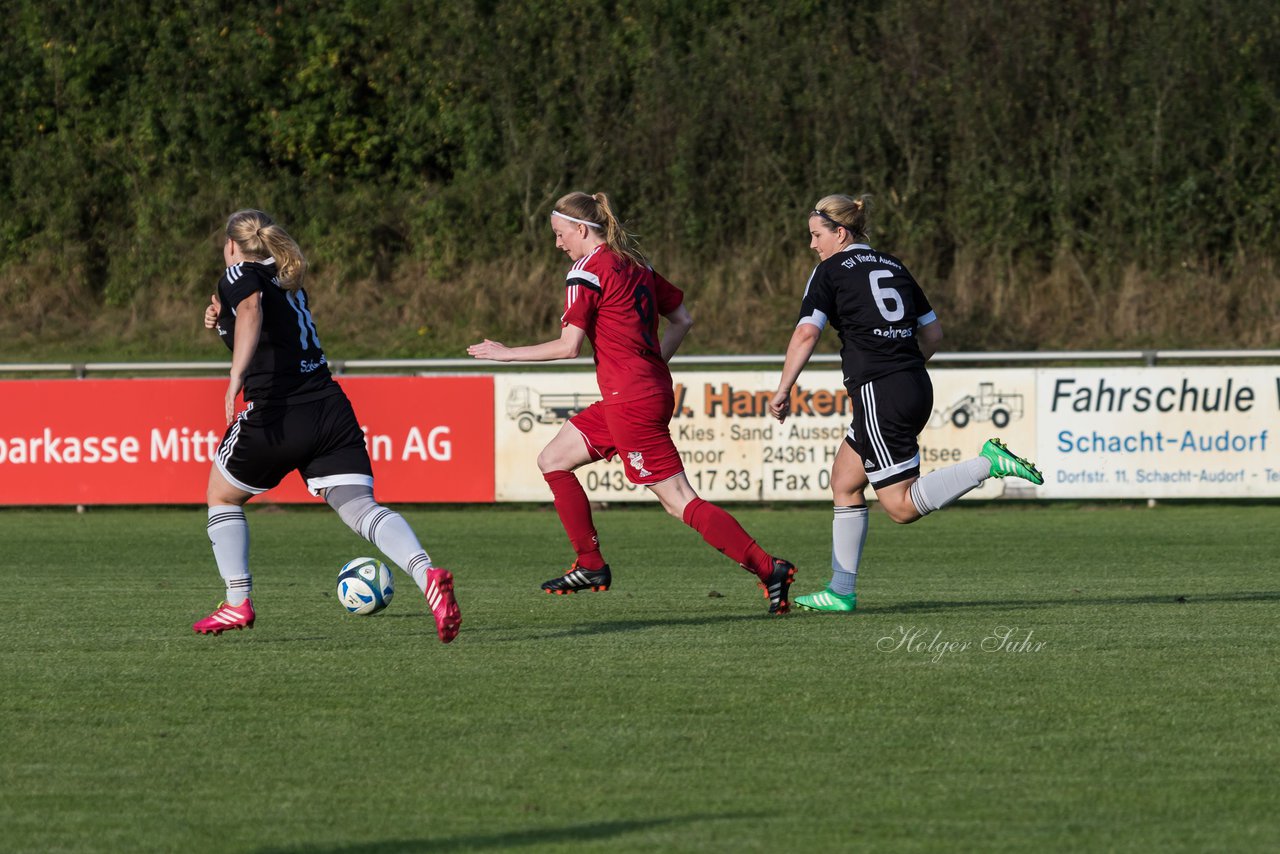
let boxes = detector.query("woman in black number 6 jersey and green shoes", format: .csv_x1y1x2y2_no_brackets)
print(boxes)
769,195,1044,612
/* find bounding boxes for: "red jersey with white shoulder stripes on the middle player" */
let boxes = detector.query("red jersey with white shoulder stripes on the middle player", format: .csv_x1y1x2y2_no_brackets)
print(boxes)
561,246,685,403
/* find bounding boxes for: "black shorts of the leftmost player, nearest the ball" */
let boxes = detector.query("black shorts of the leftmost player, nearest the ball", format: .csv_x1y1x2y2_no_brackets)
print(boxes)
214,392,374,495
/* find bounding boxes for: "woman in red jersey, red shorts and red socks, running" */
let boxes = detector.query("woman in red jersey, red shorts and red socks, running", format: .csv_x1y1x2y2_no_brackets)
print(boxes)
467,192,795,613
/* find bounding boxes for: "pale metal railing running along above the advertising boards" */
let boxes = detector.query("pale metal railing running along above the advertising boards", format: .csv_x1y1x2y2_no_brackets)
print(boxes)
0,350,1280,379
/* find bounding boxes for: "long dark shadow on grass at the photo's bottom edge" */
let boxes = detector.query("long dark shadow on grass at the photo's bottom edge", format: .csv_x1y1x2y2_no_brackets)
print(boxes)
250,813,750,854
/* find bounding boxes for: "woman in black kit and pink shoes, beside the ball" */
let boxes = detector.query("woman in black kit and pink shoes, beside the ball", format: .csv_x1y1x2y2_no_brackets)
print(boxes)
192,210,462,643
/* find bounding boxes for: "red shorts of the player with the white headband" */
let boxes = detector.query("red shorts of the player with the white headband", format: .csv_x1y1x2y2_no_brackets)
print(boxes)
568,391,685,487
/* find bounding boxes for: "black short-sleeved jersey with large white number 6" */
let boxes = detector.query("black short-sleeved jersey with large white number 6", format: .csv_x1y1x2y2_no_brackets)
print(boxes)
800,243,937,388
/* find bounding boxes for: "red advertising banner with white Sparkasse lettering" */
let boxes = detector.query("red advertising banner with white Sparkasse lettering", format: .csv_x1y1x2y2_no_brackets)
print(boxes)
0,376,494,504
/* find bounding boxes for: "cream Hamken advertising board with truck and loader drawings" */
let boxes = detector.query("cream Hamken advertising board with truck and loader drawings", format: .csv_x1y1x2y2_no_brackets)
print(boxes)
494,369,1037,501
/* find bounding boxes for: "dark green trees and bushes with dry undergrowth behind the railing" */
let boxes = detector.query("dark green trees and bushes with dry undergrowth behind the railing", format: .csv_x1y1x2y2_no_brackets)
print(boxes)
0,0,1280,359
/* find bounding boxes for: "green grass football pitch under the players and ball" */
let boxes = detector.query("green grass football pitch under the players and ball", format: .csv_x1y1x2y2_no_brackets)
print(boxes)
0,504,1280,854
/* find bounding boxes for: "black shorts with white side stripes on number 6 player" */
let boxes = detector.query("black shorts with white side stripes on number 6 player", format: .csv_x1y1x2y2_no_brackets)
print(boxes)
845,370,933,487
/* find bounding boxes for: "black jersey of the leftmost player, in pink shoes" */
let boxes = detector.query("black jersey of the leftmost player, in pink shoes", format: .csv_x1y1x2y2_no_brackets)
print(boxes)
218,259,340,403
